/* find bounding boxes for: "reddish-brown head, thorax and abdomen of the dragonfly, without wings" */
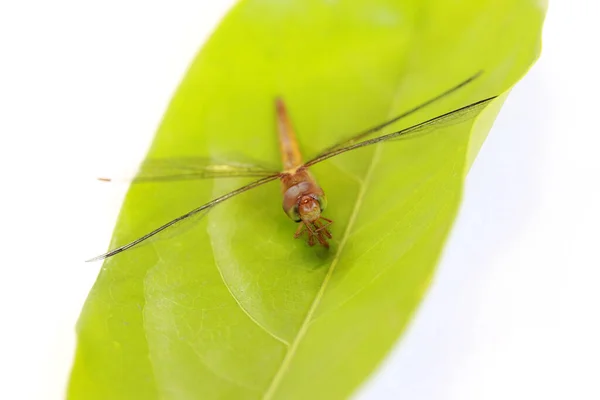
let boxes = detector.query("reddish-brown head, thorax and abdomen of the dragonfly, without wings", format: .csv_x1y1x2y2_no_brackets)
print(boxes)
275,98,333,247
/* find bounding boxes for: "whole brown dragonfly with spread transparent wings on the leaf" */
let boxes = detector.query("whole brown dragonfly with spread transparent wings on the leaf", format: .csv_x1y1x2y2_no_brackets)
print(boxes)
87,71,497,262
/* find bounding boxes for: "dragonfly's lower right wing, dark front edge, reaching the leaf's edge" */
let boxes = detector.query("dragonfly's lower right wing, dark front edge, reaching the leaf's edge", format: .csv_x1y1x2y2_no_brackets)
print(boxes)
304,96,497,167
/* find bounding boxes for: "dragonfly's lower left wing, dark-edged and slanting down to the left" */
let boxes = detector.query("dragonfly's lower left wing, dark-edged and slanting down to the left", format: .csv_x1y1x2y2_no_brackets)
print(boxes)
87,174,279,262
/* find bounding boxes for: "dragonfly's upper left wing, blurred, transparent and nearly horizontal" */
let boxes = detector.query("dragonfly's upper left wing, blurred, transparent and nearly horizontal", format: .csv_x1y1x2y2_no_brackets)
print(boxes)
99,157,278,183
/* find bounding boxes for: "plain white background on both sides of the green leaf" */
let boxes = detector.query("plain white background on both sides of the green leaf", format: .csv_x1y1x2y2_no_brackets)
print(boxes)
0,0,600,400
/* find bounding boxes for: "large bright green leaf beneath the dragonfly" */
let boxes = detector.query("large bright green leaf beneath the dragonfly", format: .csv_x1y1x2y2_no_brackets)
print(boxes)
68,0,545,399
